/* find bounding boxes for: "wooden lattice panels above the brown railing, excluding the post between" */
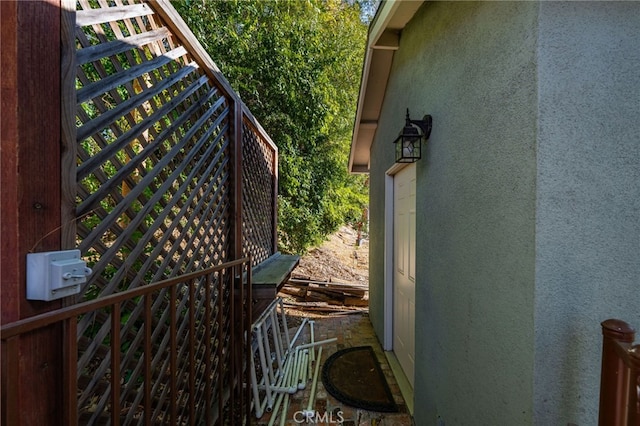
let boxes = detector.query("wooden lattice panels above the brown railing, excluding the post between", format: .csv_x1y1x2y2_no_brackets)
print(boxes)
74,0,276,298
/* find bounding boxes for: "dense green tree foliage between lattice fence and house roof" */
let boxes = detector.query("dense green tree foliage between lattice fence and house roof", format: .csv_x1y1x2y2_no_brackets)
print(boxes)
174,0,371,253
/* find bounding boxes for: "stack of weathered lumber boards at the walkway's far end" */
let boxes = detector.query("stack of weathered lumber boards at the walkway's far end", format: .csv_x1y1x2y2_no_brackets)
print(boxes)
280,277,369,312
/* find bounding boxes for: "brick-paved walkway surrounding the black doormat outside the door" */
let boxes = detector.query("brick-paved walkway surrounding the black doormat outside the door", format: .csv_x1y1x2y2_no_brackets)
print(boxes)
254,314,413,426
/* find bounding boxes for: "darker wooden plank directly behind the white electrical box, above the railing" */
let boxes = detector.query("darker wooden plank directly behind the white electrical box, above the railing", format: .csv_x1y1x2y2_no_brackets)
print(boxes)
13,2,61,302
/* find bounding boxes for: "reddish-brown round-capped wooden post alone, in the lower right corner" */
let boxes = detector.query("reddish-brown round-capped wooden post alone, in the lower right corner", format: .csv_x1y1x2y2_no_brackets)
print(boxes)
598,319,635,426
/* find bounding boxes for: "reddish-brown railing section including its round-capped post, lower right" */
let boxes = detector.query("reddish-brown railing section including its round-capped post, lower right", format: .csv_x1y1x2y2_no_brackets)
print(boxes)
598,319,640,426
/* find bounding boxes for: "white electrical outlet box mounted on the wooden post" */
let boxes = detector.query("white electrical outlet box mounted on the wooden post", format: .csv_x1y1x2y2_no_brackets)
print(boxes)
27,250,91,301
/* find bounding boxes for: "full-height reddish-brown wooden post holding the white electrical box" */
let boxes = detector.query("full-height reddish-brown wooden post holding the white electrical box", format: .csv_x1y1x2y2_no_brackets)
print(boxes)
0,0,66,426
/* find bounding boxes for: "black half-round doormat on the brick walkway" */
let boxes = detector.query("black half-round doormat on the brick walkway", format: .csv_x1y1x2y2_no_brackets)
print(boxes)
322,346,398,412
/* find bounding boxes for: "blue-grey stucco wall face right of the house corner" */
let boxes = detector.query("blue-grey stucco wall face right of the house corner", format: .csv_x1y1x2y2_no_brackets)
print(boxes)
535,2,640,426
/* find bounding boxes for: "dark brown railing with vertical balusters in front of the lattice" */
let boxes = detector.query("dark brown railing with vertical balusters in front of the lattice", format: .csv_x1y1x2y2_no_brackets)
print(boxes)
0,259,252,426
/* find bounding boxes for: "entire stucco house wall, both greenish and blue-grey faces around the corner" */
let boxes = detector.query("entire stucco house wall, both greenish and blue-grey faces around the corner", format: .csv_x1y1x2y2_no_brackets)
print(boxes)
370,2,640,426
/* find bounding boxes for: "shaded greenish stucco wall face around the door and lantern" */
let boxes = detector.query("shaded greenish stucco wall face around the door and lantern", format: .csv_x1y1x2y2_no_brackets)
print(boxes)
371,2,538,426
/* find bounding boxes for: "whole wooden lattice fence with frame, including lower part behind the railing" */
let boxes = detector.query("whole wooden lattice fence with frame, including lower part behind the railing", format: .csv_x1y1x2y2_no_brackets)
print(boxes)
23,0,277,424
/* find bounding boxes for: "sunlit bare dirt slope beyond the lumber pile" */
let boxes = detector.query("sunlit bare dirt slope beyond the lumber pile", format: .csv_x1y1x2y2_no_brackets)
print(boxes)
293,226,369,284
